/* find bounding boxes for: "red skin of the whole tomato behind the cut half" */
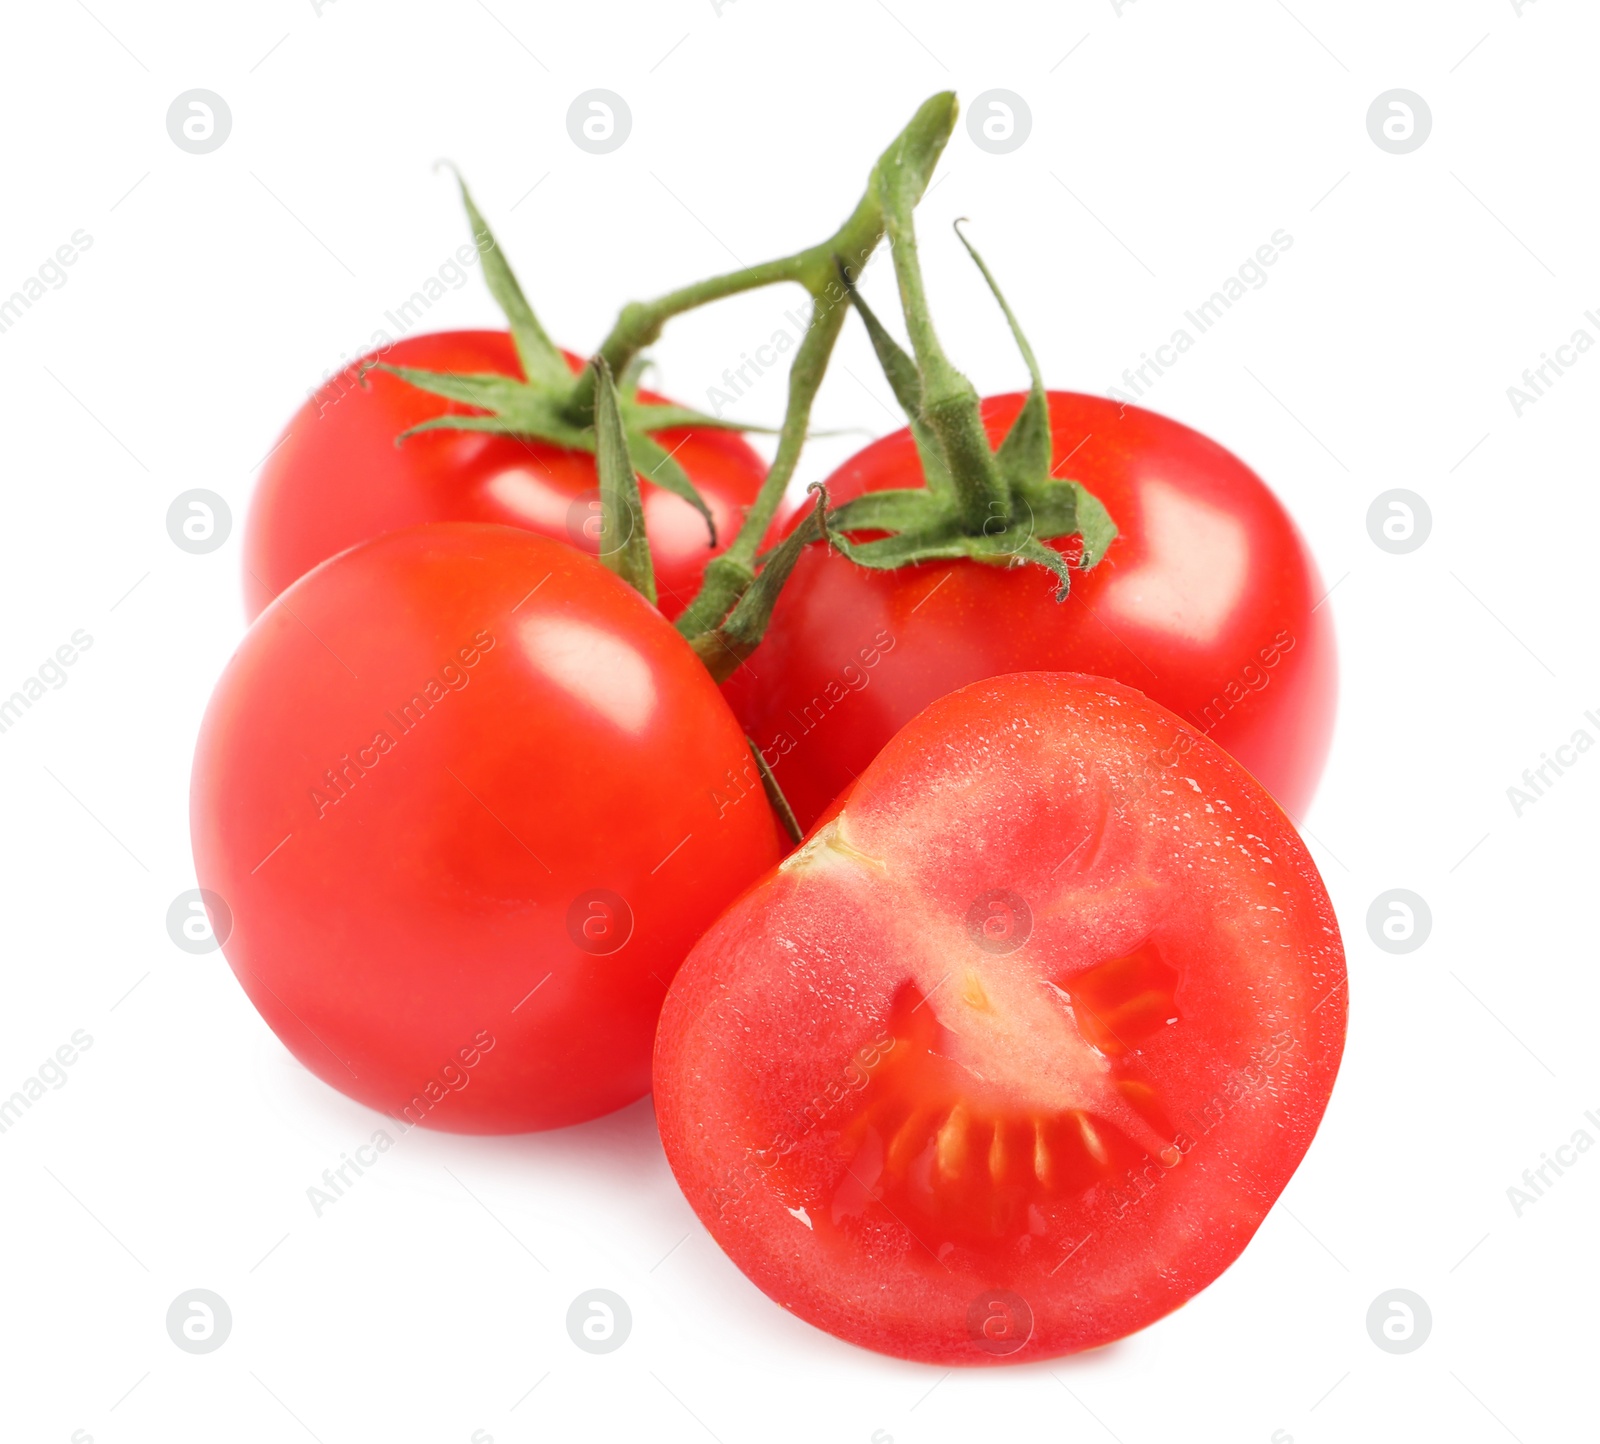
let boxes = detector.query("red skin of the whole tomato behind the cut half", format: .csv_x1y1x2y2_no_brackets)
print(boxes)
725,392,1338,826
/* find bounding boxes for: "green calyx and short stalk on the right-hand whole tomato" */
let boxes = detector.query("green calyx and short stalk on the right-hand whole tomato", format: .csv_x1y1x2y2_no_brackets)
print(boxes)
827,204,1117,600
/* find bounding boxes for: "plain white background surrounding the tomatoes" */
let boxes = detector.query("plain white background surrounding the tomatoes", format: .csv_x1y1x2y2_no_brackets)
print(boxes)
0,0,1600,1444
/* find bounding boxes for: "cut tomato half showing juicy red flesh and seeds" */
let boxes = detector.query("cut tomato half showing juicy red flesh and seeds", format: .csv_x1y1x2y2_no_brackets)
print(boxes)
656,672,1346,1364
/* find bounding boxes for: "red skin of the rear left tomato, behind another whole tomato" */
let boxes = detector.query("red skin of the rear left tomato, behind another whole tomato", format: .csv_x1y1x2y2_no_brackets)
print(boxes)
245,331,766,618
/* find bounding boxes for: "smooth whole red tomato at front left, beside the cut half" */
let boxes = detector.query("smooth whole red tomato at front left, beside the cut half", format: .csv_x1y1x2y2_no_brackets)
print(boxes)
190,523,784,1133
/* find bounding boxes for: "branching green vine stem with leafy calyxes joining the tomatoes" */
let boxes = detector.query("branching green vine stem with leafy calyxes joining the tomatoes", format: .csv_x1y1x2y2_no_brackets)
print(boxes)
379,93,1117,682
